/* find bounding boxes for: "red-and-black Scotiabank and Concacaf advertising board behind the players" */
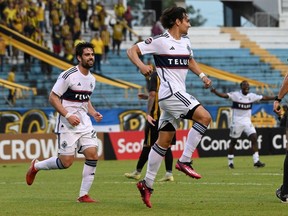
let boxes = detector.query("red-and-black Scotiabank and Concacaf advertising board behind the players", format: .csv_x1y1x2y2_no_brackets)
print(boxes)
103,128,287,160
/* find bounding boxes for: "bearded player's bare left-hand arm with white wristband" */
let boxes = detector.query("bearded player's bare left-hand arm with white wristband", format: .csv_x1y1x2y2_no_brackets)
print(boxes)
49,91,80,126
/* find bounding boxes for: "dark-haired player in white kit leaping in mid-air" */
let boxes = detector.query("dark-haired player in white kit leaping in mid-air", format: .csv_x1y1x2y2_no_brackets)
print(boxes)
127,7,211,208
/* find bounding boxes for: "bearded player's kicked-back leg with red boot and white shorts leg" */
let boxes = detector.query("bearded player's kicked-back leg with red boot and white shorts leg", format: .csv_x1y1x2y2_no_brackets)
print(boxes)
26,133,79,185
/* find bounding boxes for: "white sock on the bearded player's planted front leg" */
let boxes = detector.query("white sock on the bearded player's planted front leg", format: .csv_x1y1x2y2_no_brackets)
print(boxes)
79,160,97,197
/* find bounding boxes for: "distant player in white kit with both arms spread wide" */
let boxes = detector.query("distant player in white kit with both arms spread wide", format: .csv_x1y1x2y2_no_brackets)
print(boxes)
211,80,275,169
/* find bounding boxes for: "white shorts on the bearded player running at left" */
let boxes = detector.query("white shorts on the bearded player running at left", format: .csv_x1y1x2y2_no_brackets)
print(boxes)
58,130,98,155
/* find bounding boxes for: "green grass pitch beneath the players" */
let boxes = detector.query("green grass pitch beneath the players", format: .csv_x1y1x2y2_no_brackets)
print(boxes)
0,155,288,216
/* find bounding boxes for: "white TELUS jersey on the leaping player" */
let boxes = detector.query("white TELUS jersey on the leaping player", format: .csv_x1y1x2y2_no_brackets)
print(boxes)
137,31,193,101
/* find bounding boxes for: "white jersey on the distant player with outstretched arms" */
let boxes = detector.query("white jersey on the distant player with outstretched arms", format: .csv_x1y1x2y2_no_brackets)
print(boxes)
227,91,263,123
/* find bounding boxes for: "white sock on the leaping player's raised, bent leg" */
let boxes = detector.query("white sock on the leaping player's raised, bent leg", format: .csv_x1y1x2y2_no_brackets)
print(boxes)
179,123,207,162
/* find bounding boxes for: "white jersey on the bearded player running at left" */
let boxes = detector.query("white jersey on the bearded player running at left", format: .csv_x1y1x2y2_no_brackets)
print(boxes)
52,66,96,133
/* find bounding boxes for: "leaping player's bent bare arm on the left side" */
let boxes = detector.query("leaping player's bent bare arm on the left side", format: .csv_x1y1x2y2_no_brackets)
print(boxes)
127,45,153,76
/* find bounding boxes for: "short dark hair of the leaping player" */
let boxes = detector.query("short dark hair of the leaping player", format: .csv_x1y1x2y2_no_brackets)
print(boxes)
160,6,187,29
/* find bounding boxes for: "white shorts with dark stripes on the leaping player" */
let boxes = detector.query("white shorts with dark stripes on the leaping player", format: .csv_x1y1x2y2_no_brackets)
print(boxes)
158,92,200,130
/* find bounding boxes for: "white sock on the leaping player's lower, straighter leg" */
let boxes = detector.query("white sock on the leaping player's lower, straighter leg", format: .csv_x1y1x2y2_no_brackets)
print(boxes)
144,143,167,188
